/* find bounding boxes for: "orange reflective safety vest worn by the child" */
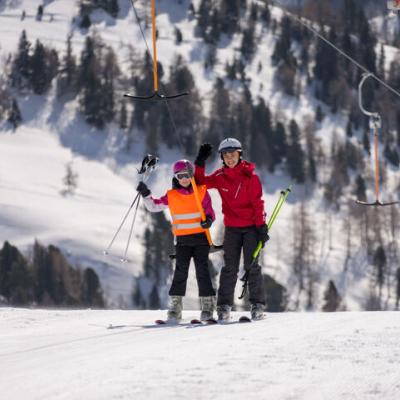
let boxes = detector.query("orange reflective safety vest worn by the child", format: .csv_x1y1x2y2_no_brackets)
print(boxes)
167,186,207,236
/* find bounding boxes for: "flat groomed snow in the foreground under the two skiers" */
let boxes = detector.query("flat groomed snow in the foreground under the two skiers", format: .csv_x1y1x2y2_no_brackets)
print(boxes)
0,308,400,400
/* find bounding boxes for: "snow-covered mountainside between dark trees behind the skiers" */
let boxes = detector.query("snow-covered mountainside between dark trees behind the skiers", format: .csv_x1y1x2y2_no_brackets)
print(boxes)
0,0,398,310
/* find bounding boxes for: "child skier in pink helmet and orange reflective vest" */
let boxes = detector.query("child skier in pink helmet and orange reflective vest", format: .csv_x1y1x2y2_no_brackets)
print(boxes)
136,160,216,322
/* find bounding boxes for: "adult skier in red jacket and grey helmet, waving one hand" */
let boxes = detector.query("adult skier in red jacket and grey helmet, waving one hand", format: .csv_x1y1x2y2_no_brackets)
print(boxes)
195,138,269,320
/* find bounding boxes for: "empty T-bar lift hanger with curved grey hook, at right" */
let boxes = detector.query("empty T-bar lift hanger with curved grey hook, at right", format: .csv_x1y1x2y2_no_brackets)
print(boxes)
356,72,399,206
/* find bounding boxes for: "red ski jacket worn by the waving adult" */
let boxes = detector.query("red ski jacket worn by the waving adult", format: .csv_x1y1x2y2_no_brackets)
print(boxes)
194,160,266,227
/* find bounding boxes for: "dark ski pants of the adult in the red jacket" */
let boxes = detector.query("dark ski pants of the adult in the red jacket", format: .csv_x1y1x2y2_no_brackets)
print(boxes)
217,226,265,306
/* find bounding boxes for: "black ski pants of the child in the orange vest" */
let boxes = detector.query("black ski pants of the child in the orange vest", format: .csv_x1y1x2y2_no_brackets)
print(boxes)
169,234,215,297
